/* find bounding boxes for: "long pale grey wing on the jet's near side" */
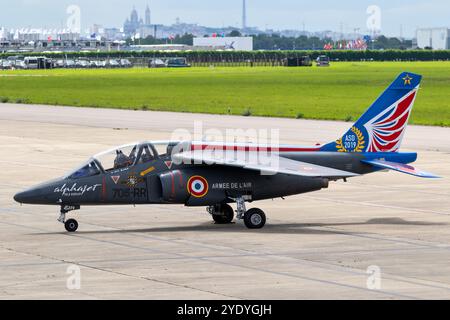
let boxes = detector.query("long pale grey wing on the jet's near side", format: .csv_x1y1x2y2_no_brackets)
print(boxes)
173,150,358,178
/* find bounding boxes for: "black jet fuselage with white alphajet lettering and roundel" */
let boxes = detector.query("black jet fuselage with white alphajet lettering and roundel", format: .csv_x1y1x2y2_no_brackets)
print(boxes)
15,152,373,206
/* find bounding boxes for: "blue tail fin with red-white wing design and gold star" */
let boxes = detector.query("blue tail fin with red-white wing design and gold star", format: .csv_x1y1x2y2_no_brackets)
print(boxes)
321,72,422,152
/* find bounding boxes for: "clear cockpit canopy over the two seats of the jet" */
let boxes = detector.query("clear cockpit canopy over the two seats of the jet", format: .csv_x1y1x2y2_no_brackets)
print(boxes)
66,142,186,179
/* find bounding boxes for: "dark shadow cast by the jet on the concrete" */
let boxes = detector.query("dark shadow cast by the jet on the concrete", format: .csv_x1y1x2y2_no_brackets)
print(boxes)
33,218,447,235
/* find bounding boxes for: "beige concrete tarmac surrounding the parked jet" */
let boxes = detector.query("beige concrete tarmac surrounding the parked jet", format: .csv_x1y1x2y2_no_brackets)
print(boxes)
0,104,450,300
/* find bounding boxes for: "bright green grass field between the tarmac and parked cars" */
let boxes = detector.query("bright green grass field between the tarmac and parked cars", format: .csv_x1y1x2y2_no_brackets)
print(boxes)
0,62,450,126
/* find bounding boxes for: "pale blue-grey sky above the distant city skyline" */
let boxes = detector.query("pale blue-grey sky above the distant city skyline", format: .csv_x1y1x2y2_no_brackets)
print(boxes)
0,0,450,37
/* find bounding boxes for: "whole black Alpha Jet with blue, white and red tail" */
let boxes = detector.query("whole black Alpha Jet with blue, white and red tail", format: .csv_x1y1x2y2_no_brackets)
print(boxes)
14,73,437,232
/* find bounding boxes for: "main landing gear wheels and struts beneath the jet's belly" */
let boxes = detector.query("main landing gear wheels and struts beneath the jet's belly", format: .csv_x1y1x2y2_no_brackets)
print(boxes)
207,197,267,229
